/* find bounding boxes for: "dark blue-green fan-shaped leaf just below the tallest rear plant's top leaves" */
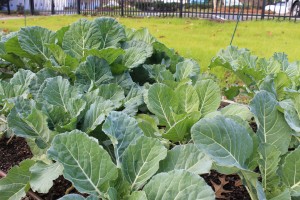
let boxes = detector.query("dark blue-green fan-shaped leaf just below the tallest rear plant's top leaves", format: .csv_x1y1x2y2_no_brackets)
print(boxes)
76,56,113,86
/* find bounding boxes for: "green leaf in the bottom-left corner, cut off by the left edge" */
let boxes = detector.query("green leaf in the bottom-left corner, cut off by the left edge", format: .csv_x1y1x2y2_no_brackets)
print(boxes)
0,160,35,200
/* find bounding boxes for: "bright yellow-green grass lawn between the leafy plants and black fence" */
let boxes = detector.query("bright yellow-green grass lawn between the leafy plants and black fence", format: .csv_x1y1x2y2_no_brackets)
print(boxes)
0,15,300,82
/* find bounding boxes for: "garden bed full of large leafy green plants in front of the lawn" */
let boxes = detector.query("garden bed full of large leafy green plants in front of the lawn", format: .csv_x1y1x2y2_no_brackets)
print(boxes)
0,18,300,200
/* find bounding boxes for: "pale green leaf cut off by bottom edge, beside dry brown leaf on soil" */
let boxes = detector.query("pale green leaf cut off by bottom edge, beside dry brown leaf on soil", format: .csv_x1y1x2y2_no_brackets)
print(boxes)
143,170,215,200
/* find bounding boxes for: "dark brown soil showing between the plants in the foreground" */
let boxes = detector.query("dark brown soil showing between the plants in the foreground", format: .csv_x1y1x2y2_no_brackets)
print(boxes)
0,137,250,200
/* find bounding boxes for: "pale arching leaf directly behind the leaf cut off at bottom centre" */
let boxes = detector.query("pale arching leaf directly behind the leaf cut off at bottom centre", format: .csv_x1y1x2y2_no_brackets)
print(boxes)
159,144,212,174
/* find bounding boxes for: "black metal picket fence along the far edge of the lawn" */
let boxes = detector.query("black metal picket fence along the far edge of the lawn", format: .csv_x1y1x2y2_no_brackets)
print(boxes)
0,0,300,20
